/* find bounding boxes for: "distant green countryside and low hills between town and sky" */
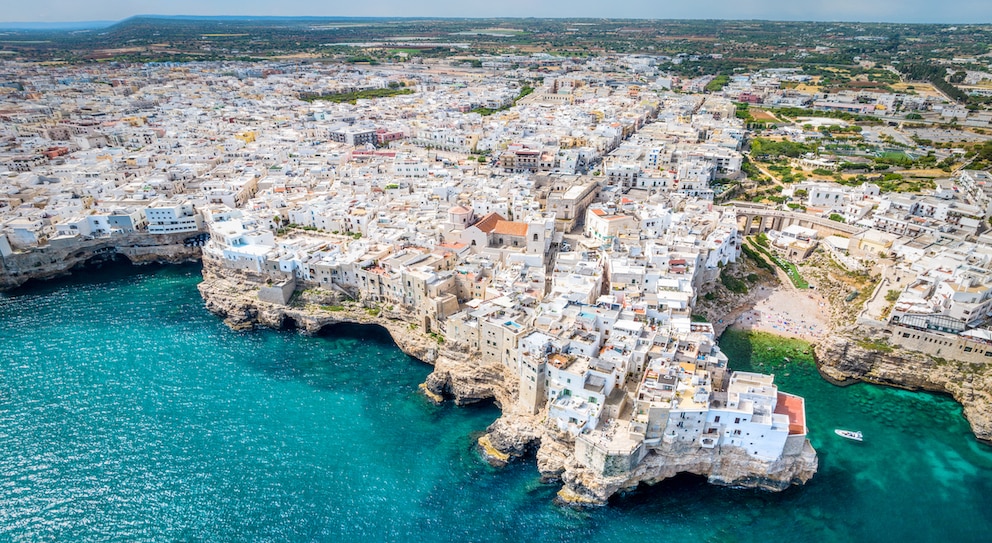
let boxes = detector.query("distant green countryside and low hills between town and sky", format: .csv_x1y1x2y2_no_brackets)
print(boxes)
0,13,992,74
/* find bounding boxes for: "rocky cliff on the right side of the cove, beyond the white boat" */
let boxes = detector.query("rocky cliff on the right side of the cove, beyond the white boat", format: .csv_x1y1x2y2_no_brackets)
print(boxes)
815,328,992,442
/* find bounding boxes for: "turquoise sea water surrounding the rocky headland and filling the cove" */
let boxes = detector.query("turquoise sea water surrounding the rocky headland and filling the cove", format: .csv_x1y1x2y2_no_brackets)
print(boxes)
0,266,992,543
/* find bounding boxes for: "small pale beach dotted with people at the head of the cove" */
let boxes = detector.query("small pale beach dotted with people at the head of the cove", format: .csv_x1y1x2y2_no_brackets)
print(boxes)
727,287,830,342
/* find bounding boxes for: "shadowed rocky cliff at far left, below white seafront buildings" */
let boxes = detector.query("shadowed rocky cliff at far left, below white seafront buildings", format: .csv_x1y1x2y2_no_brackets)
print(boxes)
0,233,200,290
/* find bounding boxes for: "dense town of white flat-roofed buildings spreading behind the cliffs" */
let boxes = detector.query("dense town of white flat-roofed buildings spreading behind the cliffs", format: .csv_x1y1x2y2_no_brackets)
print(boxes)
0,49,992,504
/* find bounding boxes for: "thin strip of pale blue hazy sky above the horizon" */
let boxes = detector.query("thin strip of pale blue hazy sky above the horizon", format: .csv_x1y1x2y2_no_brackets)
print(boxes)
0,0,992,23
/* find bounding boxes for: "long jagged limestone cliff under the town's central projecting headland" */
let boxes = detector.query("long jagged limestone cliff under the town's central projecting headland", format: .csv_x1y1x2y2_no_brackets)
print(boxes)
199,263,817,505
